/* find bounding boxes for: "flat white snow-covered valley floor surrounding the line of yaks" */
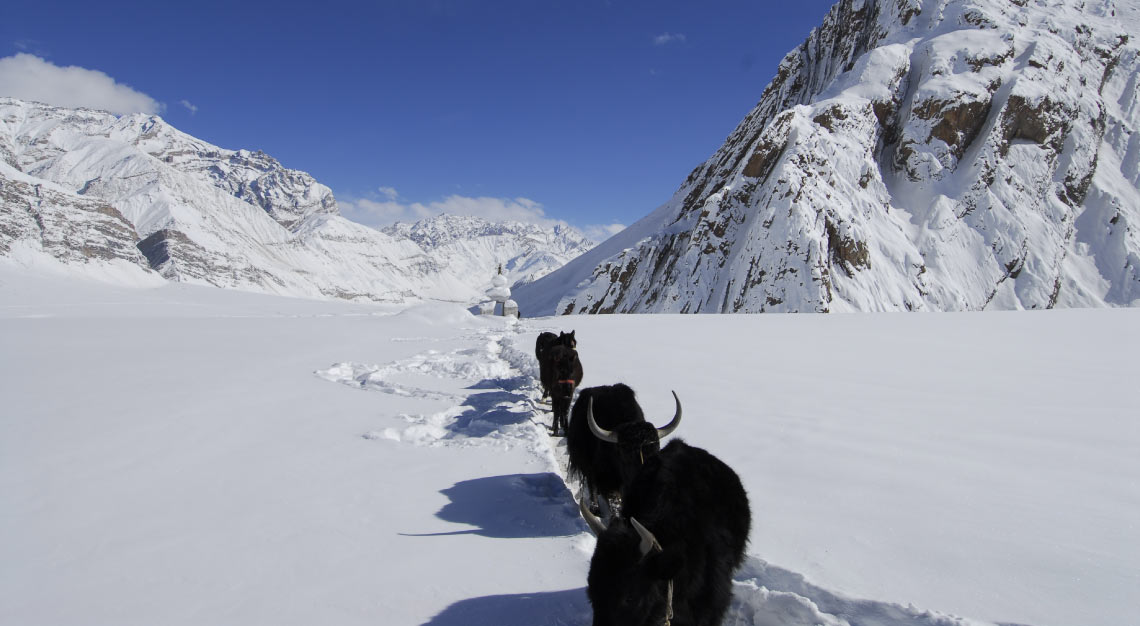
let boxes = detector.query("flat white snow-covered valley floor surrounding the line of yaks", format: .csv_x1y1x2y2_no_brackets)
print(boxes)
0,266,1140,626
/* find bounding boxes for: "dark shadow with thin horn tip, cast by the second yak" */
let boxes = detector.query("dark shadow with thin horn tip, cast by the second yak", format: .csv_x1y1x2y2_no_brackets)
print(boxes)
401,472,586,539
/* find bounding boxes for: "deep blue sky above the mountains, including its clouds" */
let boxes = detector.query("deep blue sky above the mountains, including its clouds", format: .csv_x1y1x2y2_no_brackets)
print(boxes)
0,0,832,236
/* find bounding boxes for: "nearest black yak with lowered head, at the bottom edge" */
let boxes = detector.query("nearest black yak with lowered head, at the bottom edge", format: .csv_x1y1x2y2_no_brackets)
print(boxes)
579,439,751,626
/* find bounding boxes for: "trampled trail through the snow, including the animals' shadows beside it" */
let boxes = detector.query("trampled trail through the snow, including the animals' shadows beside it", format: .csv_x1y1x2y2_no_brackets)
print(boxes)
316,322,987,626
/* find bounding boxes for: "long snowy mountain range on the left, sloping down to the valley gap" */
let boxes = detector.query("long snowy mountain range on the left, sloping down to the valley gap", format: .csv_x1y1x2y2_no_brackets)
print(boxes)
0,98,587,302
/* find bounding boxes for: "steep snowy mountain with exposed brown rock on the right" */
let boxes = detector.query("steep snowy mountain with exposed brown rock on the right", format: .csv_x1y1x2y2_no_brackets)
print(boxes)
515,0,1140,315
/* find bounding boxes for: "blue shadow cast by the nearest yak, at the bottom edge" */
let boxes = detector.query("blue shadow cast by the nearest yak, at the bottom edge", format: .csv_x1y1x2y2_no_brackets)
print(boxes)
424,587,592,626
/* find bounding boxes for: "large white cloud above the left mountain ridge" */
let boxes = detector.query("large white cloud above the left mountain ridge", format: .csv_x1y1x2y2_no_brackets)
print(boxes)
0,52,163,114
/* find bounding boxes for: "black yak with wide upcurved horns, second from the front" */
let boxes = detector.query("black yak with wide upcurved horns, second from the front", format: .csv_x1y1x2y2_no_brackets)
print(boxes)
567,383,681,517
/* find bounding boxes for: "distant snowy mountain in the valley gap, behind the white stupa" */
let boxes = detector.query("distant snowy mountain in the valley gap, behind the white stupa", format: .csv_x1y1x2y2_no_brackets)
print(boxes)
383,214,594,285
